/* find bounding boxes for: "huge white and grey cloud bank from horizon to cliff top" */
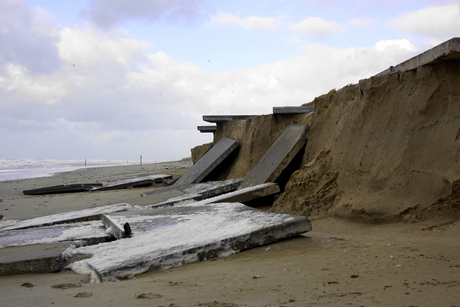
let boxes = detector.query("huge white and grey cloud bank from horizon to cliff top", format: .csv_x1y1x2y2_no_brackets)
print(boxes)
0,2,424,160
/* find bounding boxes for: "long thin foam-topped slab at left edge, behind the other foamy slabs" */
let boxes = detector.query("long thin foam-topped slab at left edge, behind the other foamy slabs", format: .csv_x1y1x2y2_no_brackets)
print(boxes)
0,203,132,231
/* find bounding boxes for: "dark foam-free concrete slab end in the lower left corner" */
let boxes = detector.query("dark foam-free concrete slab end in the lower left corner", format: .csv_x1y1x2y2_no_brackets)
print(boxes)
0,242,71,276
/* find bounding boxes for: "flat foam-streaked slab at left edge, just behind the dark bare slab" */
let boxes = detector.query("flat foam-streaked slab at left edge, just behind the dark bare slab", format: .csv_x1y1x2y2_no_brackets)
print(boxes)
0,221,111,249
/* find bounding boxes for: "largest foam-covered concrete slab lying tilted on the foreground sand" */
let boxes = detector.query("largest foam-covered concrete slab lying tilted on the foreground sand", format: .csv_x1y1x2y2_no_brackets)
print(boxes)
69,202,311,281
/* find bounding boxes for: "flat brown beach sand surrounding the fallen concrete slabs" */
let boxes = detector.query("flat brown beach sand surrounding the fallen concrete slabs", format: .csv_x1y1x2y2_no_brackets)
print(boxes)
0,161,460,306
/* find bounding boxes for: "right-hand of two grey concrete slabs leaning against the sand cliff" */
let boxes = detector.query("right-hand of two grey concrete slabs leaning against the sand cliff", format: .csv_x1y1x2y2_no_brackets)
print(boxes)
239,125,307,189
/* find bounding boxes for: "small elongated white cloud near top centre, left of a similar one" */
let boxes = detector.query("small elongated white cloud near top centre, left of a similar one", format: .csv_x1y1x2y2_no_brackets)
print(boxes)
211,13,280,30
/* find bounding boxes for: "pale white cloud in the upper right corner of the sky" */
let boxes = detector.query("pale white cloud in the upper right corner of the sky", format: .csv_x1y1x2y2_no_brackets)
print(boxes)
390,4,460,39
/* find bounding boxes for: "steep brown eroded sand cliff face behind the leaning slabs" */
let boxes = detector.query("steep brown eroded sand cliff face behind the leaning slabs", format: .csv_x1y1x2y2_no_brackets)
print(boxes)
198,61,460,221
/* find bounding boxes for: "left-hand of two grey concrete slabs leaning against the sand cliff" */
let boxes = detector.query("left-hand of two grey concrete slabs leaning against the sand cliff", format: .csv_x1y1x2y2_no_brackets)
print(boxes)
174,138,239,186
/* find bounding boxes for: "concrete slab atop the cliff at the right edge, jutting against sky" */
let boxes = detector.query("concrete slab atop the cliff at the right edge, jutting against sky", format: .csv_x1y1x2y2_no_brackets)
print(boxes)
376,37,460,76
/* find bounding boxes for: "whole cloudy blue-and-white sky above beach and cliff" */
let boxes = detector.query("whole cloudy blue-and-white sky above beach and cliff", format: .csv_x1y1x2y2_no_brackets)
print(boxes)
0,0,460,161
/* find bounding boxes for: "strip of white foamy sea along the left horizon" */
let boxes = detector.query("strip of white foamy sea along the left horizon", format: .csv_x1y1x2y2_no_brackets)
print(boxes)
0,159,140,181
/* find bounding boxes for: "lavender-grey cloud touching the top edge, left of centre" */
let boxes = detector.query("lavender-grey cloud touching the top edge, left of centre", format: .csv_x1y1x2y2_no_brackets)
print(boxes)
82,0,207,29
